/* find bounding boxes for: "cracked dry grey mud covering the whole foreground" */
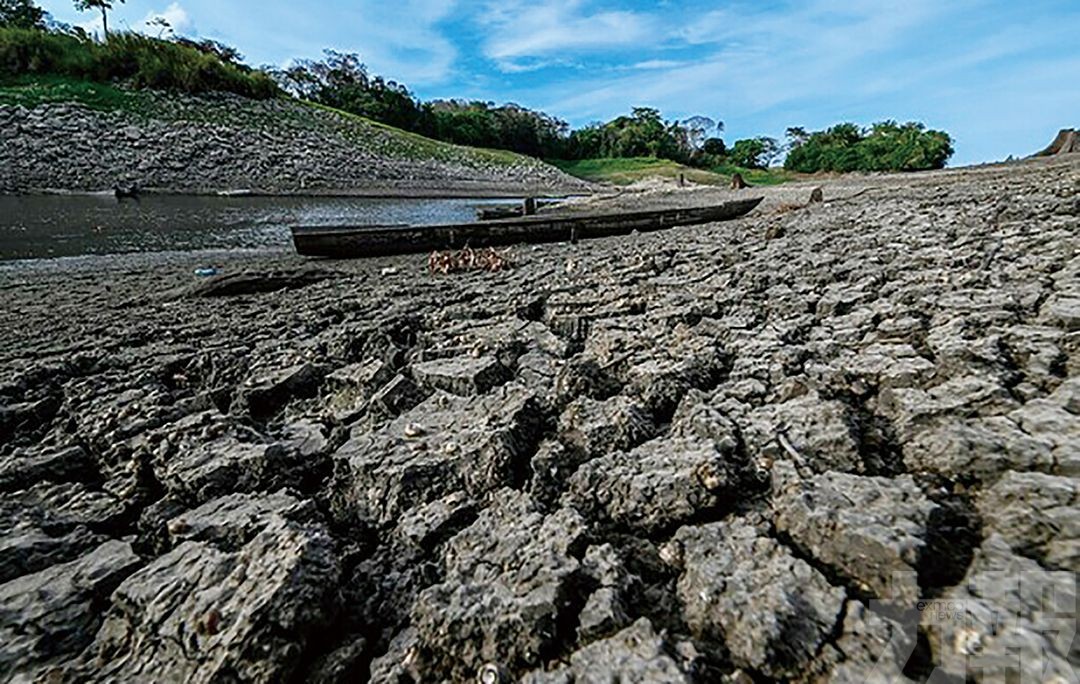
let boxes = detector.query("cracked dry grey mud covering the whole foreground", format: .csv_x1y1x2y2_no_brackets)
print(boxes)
0,159,1080,683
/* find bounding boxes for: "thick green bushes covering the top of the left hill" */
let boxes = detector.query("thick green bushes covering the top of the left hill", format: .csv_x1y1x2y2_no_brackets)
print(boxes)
0,28,280,98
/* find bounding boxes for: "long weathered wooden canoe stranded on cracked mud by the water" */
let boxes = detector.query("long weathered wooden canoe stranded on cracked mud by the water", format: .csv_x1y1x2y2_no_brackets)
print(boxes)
292,198,762,258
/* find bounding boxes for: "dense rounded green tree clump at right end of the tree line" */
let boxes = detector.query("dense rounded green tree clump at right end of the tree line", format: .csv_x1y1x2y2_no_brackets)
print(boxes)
784,121,953,173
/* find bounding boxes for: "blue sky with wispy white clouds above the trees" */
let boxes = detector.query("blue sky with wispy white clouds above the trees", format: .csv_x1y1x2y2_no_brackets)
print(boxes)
35,0,1080,165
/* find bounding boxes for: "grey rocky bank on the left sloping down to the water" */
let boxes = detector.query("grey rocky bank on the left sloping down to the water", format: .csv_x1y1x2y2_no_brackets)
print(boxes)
0,91,586,196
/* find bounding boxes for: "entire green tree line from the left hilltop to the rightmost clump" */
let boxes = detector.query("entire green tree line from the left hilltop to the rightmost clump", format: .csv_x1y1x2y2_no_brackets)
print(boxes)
0,0,953,173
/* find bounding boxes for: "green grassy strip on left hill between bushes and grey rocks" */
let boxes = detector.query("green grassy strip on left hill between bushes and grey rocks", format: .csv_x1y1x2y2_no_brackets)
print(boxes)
0,76,541,166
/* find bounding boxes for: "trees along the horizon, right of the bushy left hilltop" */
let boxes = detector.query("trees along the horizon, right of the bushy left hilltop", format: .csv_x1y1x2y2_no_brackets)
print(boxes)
271,51,953,173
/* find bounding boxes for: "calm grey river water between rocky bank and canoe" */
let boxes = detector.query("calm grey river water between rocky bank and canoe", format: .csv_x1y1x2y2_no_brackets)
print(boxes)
0,196,519,261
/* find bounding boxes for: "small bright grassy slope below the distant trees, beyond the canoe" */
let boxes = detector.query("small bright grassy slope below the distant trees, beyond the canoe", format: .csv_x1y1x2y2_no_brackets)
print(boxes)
548,157,789,185
